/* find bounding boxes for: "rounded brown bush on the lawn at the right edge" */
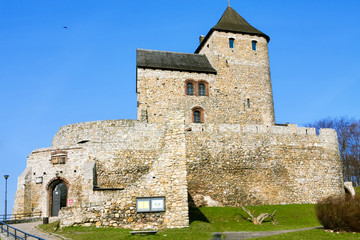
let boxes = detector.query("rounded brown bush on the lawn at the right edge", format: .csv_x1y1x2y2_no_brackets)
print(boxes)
315,196,360,232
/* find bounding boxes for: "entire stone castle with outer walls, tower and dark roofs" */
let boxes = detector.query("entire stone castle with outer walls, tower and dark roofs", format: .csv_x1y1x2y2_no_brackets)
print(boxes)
13,6,344,229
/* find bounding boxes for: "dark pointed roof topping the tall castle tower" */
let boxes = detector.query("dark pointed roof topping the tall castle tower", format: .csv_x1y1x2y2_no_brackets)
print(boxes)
195,6,270,53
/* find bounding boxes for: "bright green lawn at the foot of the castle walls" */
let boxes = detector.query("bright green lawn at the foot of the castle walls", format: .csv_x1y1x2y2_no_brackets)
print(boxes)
36,204,360,240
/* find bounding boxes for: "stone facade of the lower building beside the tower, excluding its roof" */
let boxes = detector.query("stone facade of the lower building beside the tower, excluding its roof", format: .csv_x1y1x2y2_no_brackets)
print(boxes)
137,68,217,123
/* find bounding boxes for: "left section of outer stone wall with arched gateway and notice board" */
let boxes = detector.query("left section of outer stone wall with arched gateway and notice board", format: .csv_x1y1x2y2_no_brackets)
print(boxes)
14,115,188,229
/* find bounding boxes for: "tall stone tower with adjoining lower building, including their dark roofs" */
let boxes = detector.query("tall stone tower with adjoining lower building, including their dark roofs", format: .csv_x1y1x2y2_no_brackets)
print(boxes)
137,7,275,126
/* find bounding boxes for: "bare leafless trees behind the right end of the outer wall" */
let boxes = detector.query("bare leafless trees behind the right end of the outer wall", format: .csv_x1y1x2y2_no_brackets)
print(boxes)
306,117,360,186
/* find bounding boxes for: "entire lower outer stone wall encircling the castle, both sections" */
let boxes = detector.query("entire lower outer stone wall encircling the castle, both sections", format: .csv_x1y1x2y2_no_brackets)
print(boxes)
14,117,344,229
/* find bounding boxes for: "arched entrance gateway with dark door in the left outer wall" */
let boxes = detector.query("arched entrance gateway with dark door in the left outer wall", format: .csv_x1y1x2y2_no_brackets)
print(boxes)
46,177,70,217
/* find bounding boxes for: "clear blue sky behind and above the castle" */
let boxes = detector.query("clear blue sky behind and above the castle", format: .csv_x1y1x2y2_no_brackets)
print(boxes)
0,0,360,214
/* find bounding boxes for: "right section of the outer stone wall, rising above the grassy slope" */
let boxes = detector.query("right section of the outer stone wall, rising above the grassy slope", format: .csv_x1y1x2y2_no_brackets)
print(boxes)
186,124,344,206
